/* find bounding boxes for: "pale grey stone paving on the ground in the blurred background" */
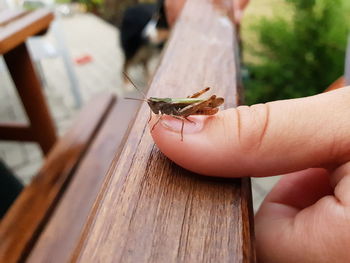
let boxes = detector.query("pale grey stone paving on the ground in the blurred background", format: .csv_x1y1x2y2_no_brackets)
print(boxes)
0,14,276,212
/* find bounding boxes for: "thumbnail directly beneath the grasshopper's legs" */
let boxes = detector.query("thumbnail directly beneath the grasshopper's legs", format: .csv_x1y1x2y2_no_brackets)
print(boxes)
160,116,206,134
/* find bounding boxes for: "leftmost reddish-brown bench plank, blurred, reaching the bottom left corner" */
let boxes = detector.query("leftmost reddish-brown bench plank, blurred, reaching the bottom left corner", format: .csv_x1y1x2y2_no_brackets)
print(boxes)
0,94,115,263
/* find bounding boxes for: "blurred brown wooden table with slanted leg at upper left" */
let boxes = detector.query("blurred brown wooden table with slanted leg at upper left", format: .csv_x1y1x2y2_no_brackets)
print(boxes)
0,9,57,154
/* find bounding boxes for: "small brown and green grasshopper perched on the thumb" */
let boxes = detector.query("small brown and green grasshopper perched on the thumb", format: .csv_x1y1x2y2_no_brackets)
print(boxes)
124,73,224,141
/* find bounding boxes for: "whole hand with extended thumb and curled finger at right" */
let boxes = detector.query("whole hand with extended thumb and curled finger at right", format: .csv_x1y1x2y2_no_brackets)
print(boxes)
150,87,350,263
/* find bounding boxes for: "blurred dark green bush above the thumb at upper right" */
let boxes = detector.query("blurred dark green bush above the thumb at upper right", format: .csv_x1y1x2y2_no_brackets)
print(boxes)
246,0,350,104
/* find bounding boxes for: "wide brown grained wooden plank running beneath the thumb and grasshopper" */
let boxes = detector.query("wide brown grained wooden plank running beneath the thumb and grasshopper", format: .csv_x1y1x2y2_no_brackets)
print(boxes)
71,0,255,262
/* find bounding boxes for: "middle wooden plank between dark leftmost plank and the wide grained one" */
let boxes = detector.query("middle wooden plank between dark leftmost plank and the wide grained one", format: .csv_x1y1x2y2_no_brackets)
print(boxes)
26,100,140,263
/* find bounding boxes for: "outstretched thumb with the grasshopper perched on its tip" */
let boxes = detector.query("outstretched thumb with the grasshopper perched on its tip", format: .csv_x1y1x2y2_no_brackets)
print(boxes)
150,87,350,177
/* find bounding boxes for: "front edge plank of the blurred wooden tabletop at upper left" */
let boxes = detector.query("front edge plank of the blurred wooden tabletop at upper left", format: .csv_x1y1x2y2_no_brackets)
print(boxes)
0,9,54,54
